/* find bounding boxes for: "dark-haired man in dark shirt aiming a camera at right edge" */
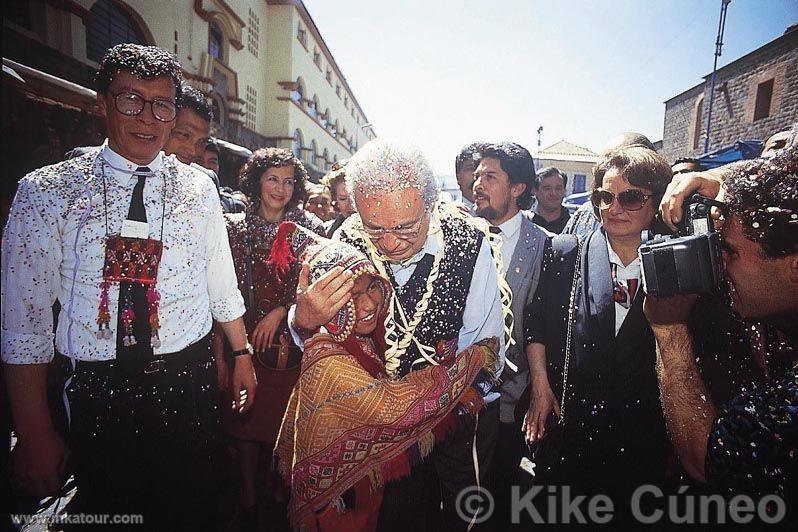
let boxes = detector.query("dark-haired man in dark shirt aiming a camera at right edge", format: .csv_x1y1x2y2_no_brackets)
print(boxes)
645,145,798,518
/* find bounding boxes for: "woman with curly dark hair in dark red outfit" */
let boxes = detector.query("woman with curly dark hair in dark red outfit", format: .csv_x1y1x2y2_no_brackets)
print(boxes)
215,148,324,521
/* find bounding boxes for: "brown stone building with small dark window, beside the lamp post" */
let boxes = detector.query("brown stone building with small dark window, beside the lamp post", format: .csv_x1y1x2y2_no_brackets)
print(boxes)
660,25,798,162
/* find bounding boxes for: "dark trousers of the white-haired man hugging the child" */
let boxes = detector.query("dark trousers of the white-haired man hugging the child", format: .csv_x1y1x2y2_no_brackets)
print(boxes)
377,400,499,532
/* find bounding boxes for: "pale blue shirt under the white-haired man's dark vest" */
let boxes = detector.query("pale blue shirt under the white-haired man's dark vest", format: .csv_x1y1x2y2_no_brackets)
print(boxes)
288,220,506,403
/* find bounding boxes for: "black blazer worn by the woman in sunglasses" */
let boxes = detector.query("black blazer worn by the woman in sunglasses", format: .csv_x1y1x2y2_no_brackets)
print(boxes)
524,229,667,482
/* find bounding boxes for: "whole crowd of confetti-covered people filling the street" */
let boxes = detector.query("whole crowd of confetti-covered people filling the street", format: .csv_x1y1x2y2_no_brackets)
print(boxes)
2,44,798,531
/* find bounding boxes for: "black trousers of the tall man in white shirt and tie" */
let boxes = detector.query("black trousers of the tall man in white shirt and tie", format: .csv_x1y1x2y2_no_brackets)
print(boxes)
62,337,222,531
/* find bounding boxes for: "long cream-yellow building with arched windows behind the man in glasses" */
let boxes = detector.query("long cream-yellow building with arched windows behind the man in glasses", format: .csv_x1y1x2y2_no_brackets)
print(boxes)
3,0,375,187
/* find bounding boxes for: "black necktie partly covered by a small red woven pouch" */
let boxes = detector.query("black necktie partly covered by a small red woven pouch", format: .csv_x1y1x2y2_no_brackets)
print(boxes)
116,166,152,356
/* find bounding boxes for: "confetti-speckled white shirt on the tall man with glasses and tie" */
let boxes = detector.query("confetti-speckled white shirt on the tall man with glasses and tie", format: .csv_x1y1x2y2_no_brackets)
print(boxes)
2,141,244,364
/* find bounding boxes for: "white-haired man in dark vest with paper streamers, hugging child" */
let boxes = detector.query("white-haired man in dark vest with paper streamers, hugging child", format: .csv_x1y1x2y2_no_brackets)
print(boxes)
289,139,509,530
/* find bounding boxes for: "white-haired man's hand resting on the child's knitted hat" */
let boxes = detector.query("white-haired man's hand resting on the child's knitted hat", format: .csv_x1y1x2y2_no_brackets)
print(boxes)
294,264,355,331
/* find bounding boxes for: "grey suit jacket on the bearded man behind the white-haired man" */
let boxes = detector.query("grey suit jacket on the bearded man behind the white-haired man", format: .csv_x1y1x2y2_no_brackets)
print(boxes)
499,211,551,423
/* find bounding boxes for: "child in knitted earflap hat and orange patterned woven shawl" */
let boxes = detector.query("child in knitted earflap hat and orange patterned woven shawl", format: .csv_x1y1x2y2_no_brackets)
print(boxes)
271,223,498,532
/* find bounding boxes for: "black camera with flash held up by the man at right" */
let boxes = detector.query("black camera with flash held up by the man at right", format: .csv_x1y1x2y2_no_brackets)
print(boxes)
638,194,726,297
